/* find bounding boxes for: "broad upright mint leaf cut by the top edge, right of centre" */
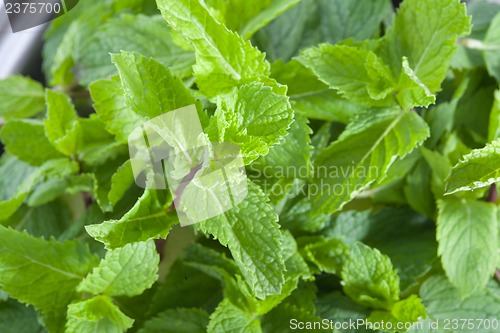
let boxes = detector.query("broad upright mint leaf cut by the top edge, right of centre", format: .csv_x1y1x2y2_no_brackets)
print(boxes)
379,0,470,94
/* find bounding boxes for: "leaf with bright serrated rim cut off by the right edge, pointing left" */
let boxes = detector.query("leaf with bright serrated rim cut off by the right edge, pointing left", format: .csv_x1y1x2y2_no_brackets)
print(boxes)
446,139,500,194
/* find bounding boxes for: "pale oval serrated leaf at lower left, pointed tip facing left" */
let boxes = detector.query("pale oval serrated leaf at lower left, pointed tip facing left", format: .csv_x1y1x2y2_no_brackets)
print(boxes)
77,241,160,296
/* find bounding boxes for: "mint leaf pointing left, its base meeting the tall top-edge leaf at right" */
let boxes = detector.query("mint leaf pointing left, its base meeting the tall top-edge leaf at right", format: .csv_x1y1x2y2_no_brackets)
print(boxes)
297,44,395,105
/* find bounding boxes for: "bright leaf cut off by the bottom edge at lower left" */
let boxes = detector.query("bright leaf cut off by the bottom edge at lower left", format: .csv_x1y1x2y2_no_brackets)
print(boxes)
66,296,134,333
